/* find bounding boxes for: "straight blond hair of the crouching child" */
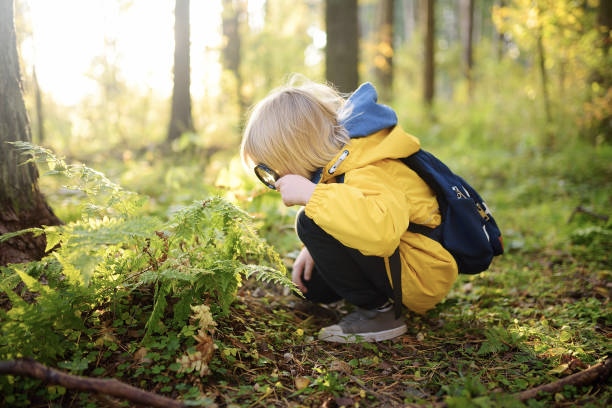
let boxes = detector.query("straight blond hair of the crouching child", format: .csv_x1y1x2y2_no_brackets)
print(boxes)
240,77,349,178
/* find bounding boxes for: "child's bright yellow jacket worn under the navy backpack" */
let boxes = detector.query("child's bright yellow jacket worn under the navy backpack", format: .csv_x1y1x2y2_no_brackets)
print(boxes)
305,125,457,313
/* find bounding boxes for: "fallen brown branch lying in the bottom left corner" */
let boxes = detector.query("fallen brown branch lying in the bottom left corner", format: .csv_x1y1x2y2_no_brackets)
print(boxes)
0,359,191,408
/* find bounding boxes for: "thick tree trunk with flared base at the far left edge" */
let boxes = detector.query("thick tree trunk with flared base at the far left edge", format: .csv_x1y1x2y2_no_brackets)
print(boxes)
0,0,61,265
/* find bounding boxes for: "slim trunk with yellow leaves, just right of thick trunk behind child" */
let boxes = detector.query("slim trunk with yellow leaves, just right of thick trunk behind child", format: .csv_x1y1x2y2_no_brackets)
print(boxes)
374,0,395,102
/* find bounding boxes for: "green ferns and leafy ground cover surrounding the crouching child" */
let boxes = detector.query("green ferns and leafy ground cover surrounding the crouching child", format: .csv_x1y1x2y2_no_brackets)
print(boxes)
0,139,612,408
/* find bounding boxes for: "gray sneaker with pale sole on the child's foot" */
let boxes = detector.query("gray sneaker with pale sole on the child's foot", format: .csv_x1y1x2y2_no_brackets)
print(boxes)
319,307,408,343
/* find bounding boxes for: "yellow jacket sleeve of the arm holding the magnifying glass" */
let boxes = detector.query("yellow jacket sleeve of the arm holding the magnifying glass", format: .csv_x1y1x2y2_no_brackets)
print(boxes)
305,161,411,257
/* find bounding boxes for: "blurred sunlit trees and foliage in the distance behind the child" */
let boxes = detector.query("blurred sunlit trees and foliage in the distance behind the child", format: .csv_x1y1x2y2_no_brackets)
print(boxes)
16,0,612,167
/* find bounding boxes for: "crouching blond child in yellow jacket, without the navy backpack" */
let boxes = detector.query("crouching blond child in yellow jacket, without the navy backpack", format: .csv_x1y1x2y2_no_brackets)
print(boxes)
241,80,457,343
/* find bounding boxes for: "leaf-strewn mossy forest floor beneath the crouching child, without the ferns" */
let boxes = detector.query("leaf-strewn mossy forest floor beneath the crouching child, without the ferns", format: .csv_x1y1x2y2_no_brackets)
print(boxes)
14,245,612,408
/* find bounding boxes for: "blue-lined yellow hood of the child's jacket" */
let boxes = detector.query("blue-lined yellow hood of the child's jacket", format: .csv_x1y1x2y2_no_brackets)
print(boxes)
313,83,420,183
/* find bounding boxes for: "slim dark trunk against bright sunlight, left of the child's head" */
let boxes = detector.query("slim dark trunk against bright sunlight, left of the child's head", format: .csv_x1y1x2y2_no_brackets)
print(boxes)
167,0,194,143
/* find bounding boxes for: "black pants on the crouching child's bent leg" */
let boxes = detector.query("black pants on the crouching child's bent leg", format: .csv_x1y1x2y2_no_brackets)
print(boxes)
296,210,393,309
